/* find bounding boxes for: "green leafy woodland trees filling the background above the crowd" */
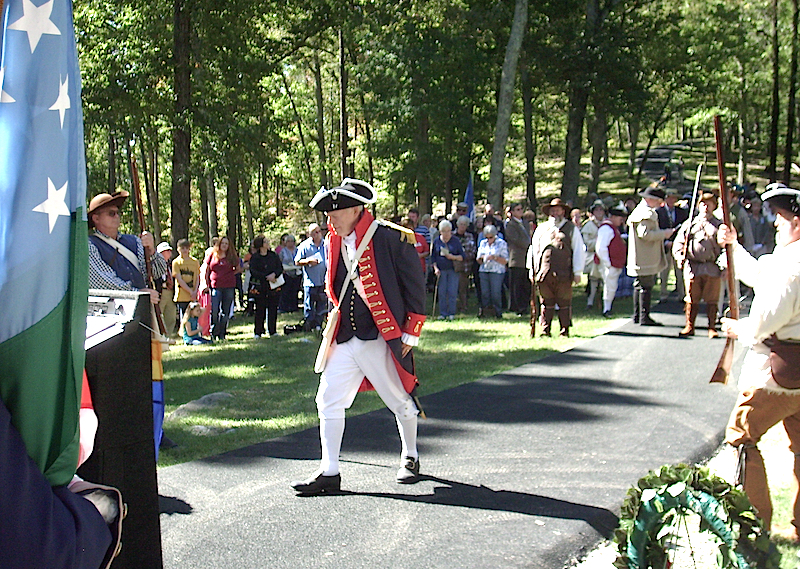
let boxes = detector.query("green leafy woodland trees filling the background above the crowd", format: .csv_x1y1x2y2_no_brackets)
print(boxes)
74,0,797,251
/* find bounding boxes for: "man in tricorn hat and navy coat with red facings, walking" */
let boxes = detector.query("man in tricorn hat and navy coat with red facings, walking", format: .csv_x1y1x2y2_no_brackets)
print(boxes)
292,178,425,495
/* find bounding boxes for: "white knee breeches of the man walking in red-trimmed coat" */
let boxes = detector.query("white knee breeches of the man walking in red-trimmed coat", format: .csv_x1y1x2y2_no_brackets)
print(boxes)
316,336,418,420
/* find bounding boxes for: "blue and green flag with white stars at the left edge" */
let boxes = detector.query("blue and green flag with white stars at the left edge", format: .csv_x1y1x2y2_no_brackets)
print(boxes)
0,0,88,485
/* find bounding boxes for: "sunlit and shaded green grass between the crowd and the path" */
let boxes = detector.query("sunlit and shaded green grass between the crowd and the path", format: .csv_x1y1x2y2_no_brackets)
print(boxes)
159,286,630,466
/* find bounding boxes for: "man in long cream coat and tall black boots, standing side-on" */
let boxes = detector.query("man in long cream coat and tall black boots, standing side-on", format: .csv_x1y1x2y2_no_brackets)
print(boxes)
627,184,675,326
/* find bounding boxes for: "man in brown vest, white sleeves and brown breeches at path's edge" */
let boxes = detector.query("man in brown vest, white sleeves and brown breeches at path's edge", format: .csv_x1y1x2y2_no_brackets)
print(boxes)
526,198,586,336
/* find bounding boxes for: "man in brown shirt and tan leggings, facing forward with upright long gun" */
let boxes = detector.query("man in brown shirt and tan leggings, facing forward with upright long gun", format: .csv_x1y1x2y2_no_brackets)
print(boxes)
672,192,722,338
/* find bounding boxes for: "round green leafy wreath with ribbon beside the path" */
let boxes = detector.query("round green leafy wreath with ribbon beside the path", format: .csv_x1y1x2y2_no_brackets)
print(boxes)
614,464,780,569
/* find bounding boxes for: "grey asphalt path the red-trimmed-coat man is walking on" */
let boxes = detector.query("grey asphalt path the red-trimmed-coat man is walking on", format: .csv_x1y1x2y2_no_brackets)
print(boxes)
158,301,736,569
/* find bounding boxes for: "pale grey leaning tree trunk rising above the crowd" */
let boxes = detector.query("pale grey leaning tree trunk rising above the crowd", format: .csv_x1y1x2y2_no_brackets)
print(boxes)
486,0,528,211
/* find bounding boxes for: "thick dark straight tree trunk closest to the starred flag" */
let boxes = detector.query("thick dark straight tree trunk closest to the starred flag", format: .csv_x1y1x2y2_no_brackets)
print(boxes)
171,0,192,240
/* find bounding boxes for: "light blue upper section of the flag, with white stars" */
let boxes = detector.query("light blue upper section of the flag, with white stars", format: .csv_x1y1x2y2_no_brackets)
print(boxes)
0,0,86,342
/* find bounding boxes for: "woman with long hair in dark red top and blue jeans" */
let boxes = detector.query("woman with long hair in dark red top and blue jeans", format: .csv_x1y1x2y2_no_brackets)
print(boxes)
205,235,242,340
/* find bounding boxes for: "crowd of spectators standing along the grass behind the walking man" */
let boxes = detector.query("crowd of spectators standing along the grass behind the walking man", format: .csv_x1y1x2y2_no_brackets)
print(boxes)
158,171,774,344
